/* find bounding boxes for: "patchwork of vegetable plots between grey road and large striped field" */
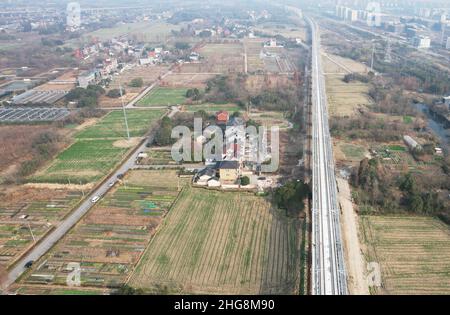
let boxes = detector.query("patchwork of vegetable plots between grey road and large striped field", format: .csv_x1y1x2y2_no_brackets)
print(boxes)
19,170,184,289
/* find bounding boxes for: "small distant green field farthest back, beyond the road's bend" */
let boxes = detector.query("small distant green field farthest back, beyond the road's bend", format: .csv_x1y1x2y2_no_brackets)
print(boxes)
137,87,187,106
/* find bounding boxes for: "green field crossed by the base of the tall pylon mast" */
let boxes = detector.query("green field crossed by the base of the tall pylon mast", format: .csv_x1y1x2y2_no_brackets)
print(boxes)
77,109,164,139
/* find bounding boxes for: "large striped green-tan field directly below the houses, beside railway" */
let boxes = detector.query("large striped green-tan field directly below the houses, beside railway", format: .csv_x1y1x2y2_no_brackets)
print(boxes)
129,187,301,294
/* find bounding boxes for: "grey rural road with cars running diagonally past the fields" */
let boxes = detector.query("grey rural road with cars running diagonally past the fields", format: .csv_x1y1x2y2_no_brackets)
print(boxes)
1,107,178,289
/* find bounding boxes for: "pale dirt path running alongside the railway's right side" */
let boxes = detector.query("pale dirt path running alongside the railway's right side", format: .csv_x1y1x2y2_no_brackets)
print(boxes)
337,178,369,295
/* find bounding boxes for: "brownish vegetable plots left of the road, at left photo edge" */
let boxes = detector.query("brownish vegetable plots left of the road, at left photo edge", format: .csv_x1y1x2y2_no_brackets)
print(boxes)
0,186,82,267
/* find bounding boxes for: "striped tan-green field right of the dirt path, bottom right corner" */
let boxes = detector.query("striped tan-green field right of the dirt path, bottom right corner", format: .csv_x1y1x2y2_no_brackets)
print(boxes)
360,216,450,294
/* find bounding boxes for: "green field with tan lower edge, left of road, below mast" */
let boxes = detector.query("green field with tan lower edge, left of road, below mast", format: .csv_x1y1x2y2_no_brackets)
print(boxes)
31,139,128,184
